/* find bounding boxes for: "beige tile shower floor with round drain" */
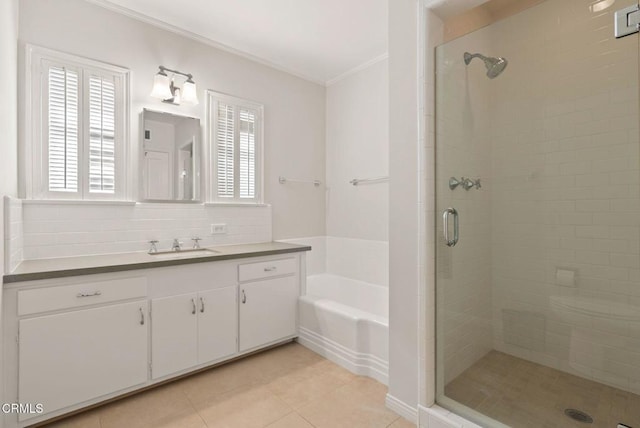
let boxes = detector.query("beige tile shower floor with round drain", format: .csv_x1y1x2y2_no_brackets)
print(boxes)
445,351,640,428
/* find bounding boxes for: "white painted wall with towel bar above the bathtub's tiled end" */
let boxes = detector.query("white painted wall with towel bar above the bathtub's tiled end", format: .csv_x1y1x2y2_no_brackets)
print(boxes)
326,59,389,241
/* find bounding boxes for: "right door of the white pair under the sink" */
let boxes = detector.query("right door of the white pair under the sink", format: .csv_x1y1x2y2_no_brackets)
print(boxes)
198,286,238,364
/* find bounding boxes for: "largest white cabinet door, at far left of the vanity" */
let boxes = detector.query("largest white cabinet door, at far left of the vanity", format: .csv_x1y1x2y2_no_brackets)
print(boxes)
18,301,148,420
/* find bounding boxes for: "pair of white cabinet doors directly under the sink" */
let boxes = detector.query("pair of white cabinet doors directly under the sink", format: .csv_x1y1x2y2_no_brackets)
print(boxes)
151,285,238,379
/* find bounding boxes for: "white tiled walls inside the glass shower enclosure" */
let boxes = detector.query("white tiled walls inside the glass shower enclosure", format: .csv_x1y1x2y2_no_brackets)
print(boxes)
436,0,640,393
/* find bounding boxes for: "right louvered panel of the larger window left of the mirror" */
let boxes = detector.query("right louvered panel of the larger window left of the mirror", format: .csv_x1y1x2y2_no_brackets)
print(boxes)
89,76,116,193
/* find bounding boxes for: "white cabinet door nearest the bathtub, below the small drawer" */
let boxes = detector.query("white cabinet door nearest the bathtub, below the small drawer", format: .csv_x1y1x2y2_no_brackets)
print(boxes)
240,276,298,351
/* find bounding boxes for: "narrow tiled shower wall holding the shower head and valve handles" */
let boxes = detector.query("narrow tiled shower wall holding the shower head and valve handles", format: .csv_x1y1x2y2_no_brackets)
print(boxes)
436,30,493,385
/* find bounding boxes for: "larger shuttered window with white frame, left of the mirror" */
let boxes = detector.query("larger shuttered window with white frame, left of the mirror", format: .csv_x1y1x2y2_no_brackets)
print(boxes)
24,46,129,200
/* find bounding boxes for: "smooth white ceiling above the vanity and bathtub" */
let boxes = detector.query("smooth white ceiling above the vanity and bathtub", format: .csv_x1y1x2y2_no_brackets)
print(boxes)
89,0,388,84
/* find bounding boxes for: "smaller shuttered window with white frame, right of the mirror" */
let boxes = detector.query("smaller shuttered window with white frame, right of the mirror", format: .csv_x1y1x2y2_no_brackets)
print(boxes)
207,91,264,204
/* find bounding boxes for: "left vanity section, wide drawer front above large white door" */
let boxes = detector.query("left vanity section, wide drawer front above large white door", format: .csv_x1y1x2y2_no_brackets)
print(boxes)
18,278,148,420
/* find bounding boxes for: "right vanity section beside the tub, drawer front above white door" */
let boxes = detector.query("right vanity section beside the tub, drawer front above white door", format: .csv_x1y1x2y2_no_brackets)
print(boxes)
239,258,300,352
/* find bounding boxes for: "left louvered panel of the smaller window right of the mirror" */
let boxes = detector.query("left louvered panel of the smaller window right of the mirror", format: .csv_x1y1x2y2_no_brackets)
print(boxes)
215,103,235,198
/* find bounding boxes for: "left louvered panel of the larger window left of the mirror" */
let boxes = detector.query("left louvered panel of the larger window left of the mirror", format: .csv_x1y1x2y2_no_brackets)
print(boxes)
46,66,79,192
